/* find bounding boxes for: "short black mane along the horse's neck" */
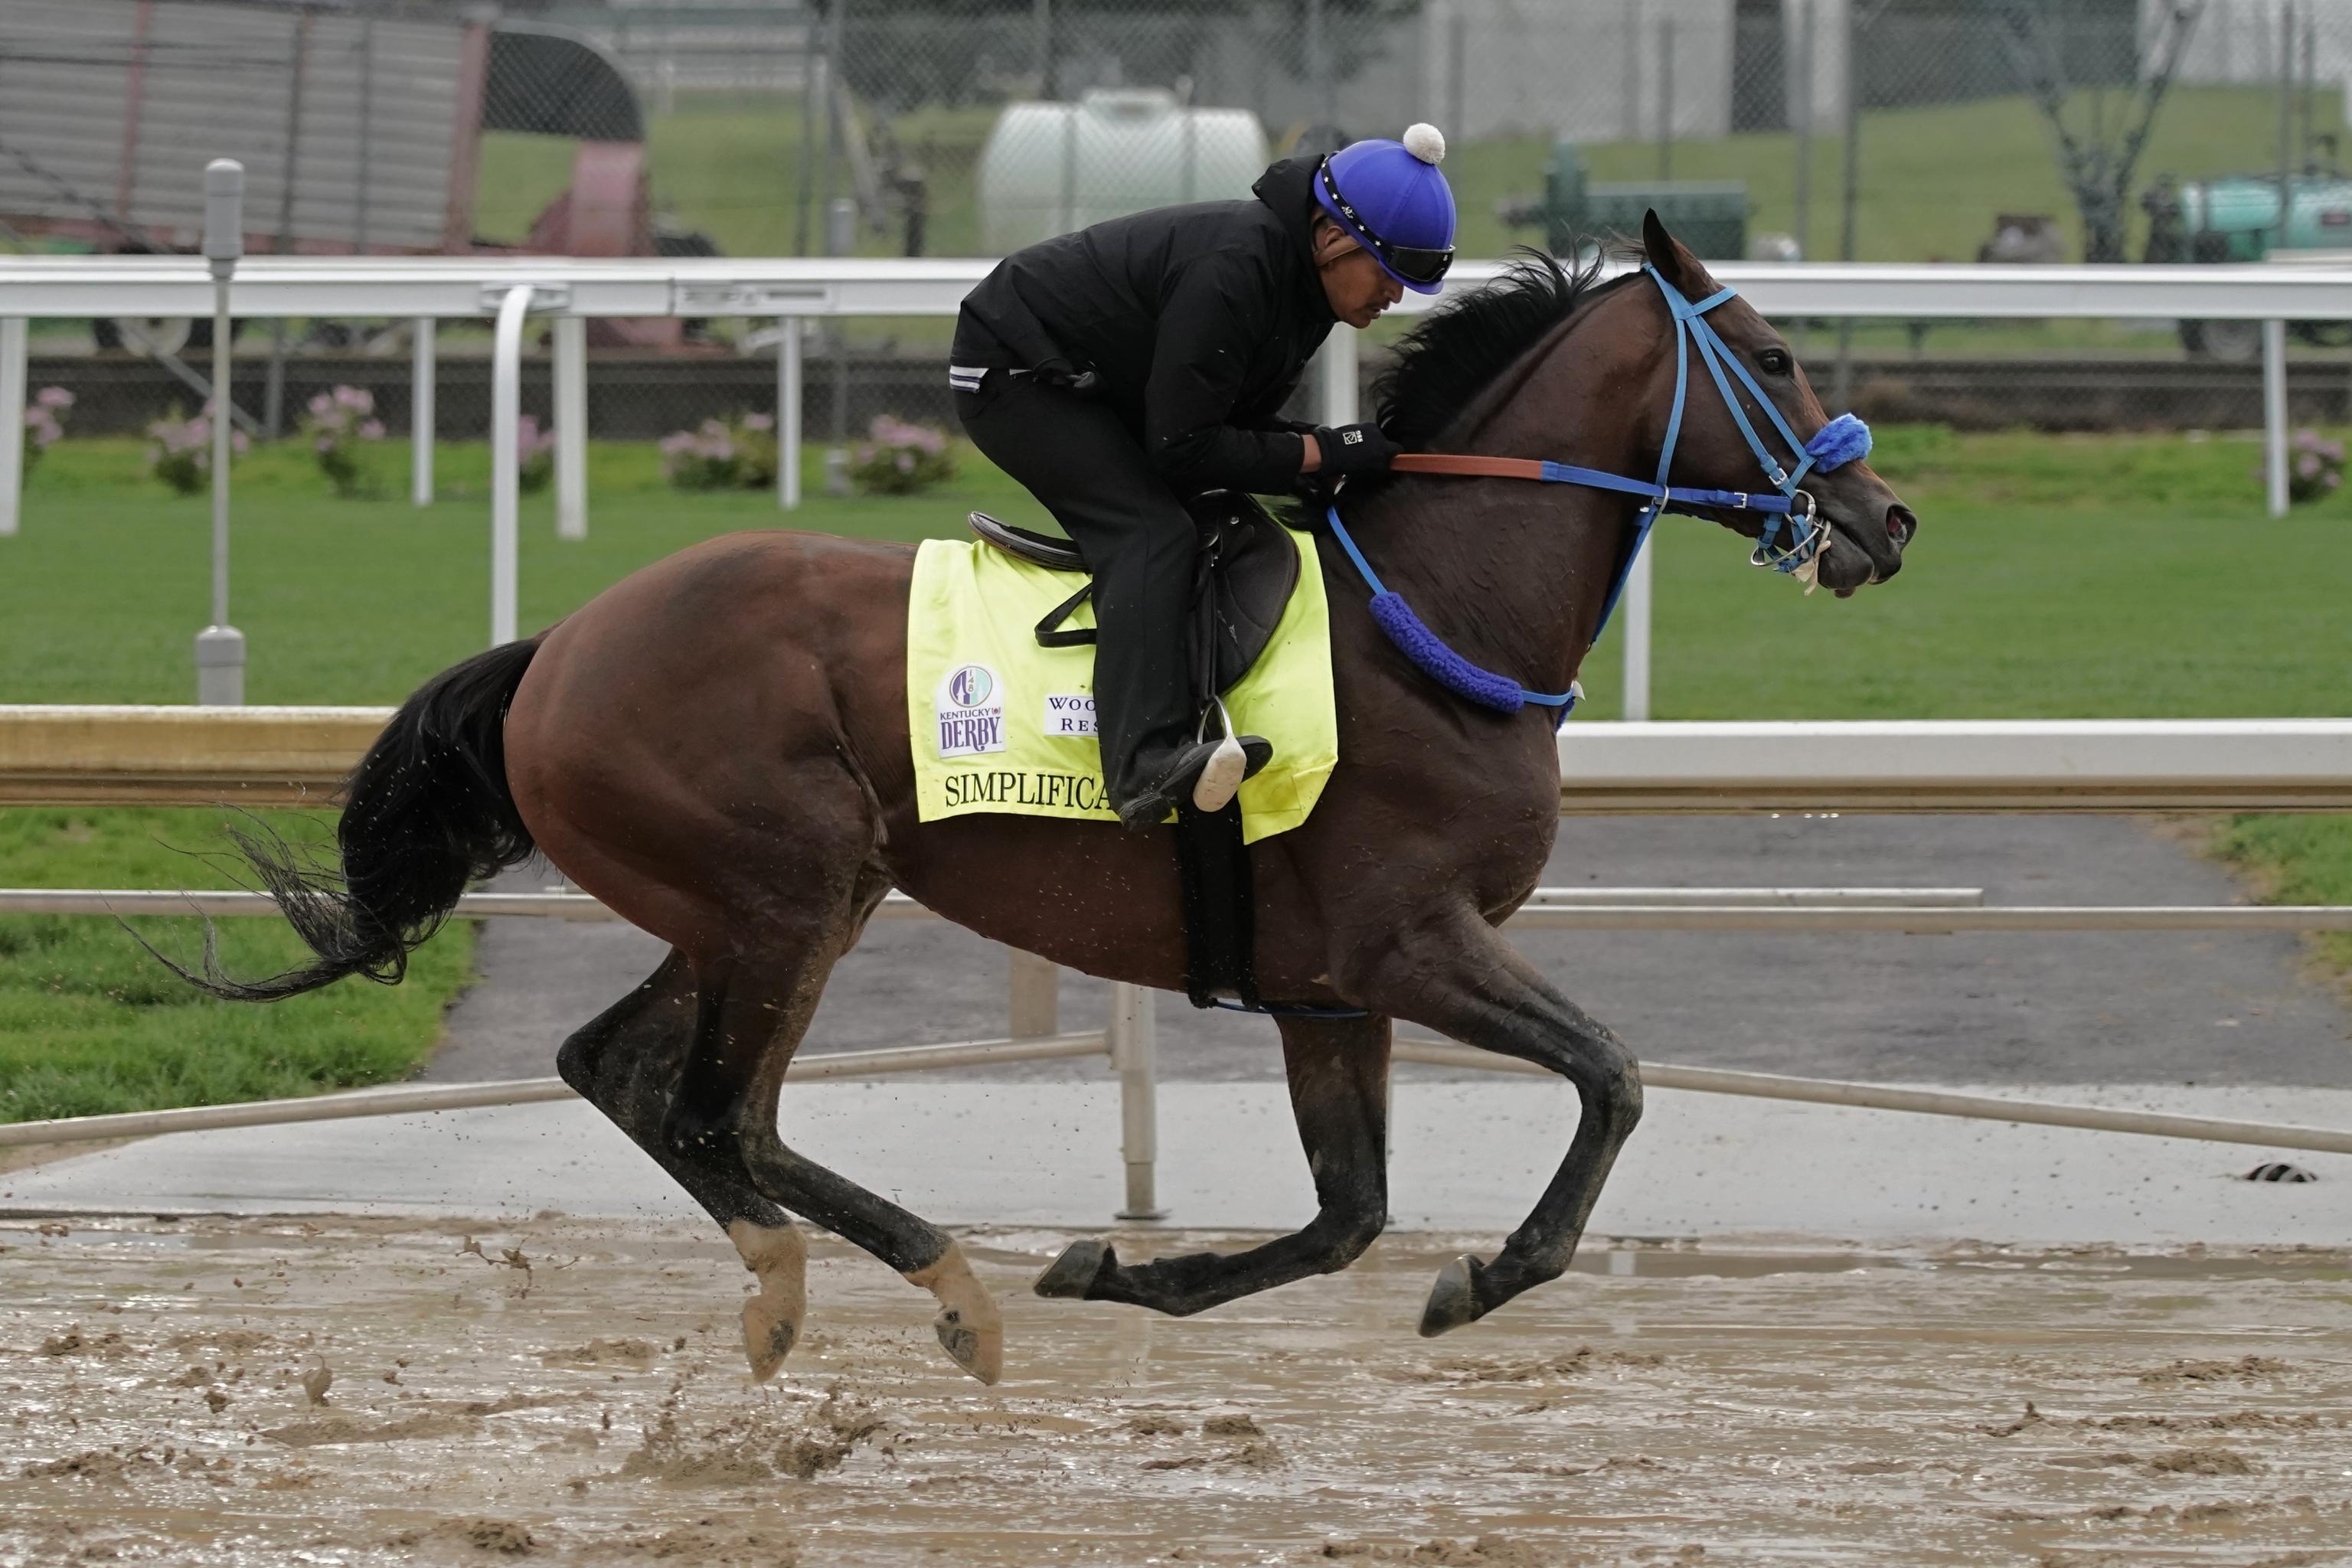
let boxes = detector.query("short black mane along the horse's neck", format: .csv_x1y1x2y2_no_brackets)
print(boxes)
1371,247,1639,452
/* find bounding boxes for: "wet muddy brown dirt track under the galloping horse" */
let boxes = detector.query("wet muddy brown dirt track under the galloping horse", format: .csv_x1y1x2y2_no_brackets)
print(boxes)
0,1218,2352,1568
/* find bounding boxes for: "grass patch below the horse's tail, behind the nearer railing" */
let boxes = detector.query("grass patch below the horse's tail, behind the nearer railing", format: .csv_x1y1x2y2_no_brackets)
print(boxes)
0,806,472,1122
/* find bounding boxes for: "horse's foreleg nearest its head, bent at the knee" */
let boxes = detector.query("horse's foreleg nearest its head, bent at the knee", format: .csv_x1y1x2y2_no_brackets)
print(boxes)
1348,910,1642,1335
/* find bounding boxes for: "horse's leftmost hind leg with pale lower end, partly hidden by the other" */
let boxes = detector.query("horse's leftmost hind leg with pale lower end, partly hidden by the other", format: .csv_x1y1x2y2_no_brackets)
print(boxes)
555,952,809,1380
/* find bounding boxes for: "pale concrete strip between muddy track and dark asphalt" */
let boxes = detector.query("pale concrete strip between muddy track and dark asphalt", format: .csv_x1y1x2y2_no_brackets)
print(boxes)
0,1079,2352,1248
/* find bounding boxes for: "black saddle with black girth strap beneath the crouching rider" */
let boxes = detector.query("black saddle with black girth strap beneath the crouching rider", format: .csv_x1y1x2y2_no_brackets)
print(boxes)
972,489,1298,1011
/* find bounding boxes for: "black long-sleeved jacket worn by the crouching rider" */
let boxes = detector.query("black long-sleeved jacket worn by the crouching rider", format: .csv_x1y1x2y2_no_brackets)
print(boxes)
952,158,1336,496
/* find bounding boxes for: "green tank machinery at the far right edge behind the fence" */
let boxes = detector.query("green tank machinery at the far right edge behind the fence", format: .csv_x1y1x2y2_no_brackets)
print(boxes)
2141,167,2352,360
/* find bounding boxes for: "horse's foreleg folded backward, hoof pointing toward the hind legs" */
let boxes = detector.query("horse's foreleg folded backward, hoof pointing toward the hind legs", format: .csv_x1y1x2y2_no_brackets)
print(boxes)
1037,1018,1387,1316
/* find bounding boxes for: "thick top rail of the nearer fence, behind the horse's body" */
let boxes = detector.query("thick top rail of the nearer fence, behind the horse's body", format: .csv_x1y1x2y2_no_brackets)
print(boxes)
0,705,2352,813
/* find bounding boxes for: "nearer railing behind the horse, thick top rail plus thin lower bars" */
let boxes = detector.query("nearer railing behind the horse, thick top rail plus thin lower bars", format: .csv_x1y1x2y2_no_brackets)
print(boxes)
0,707,2352,1215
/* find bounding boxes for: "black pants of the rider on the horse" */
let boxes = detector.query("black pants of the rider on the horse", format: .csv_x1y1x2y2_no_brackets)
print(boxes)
955,371,1197,802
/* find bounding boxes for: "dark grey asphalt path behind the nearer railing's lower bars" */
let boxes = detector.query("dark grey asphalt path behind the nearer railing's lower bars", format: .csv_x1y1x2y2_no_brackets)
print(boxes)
426,815,2352,1089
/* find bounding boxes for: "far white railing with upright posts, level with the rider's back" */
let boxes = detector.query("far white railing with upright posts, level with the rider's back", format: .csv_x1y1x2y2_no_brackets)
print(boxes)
0,256,2352,717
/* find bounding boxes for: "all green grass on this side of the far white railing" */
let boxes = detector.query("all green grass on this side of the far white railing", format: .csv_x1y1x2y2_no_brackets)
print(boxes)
0,428,2352,1119
